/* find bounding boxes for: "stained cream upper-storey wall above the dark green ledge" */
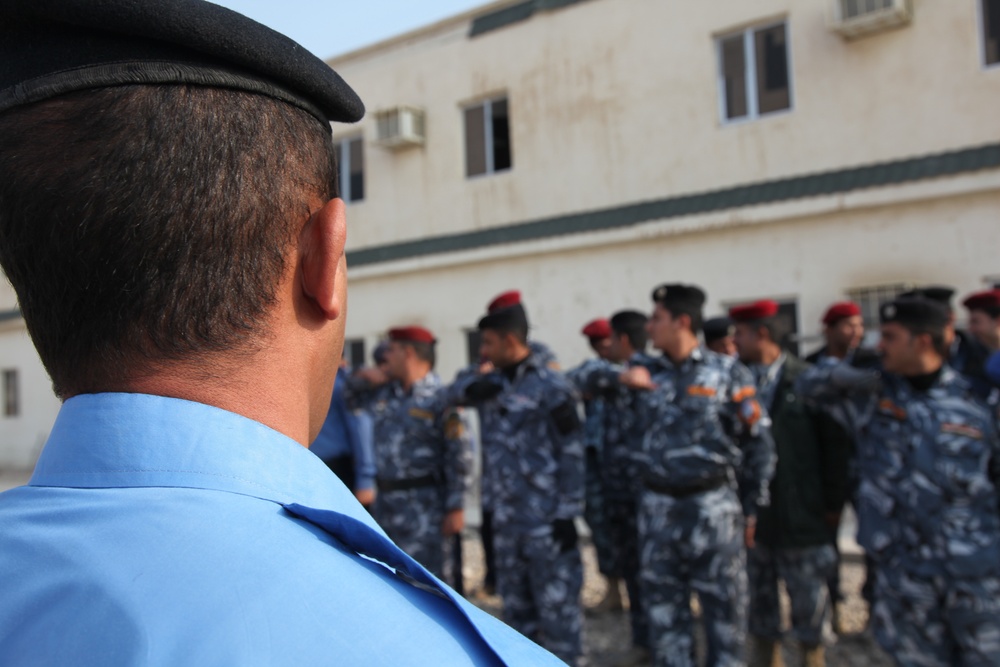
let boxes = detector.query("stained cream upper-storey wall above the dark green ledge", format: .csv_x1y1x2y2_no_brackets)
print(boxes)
331,0,1000,248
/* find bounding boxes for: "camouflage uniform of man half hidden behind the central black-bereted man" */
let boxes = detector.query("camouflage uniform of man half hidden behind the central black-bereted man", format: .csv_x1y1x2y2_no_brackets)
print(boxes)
567,353,650,647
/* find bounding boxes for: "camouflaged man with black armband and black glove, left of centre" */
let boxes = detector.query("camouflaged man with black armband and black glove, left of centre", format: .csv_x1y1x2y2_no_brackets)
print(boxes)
451,292,584,665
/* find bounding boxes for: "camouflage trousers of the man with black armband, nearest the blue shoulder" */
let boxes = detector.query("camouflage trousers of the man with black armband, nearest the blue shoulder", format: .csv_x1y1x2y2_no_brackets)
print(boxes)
493,524,583,665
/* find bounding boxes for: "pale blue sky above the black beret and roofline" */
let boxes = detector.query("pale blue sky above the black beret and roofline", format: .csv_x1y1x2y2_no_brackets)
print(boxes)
212,0,489,60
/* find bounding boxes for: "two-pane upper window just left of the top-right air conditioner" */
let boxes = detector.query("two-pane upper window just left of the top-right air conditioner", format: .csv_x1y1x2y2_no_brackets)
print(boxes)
718,23,792,121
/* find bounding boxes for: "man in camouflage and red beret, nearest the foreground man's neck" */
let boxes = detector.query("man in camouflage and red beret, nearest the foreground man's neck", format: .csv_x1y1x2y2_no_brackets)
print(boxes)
349,326,472,577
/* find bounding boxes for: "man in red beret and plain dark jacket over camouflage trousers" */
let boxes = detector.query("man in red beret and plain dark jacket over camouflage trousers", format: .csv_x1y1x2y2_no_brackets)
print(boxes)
729,300,851,667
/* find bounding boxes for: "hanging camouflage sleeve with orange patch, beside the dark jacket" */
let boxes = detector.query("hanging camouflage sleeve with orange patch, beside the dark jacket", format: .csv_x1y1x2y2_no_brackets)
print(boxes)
729,363,775,516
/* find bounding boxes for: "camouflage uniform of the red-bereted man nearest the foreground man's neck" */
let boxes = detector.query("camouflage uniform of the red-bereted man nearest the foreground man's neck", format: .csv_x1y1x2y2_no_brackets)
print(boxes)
350,373,471,577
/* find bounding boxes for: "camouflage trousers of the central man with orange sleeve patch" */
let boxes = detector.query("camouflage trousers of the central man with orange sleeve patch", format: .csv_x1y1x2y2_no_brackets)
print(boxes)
639,487,747,667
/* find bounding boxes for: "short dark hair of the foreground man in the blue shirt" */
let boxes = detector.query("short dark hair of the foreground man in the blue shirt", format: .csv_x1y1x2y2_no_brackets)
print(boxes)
0,85,337,397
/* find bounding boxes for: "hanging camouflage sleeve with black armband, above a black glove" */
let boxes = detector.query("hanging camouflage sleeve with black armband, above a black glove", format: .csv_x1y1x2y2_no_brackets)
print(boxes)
548,387,584,519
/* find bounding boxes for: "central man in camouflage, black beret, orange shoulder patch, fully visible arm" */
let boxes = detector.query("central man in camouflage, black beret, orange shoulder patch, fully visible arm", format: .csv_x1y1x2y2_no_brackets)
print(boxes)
619,284,774,667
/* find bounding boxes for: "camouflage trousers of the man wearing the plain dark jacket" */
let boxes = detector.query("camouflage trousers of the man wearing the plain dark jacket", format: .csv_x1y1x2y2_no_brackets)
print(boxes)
747,544,837,645
